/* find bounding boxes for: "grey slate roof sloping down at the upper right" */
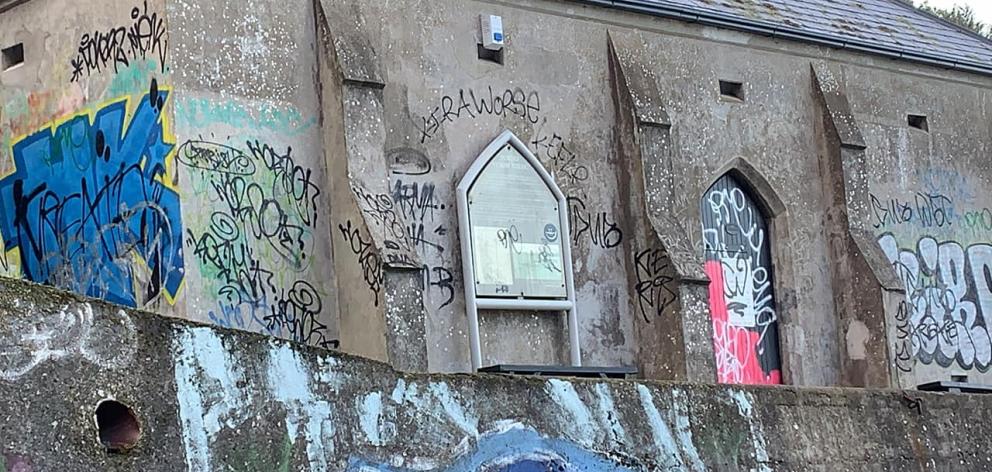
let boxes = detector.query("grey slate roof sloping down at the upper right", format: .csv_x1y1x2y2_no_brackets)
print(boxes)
578,0,992,75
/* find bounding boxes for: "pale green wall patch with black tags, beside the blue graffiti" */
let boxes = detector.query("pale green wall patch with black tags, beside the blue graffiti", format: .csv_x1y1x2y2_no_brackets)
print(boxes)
177,99,336,347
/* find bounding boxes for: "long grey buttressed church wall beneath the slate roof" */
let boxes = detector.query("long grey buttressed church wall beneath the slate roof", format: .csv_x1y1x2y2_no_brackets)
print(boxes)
320,0,992,386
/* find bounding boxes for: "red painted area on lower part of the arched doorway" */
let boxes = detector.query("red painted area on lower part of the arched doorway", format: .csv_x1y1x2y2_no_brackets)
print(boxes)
705,260,782,385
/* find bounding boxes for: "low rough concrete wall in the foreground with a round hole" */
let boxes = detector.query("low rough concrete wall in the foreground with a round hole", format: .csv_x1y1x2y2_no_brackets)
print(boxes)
0,279,992,471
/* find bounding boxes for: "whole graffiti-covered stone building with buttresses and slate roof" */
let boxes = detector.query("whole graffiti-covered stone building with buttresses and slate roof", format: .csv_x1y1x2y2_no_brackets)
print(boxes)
0,0,992,387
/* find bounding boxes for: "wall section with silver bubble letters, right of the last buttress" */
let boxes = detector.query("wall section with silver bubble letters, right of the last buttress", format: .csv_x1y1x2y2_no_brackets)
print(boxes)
848,66,992,387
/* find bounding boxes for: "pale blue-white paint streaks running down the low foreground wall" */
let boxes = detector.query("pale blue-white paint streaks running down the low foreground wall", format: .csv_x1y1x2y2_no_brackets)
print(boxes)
174,320,784,471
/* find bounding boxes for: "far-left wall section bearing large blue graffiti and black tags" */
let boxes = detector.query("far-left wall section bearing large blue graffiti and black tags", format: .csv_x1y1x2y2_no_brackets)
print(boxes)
0,2,185,313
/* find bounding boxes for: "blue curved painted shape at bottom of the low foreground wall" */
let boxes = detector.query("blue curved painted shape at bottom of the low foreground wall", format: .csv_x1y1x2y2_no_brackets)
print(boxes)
348,428,633,472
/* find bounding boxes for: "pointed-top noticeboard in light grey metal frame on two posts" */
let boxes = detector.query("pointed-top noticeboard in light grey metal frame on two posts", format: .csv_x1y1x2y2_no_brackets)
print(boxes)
458,131,582,370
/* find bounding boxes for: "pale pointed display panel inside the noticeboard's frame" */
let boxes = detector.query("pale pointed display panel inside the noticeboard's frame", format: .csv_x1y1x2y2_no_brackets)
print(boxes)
468,145,567,298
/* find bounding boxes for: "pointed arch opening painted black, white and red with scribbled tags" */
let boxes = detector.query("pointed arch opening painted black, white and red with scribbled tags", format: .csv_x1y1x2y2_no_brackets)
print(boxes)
700,174,782,384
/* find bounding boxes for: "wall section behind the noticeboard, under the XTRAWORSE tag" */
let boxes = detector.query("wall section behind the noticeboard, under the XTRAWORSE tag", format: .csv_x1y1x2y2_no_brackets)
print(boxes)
321,0,635,371
